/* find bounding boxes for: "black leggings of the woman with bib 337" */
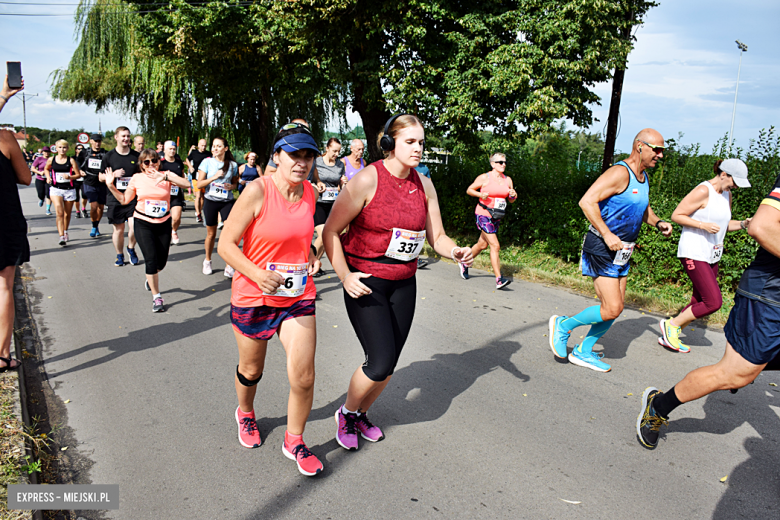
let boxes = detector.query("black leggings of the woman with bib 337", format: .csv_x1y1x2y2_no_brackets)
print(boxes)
344,266,417,382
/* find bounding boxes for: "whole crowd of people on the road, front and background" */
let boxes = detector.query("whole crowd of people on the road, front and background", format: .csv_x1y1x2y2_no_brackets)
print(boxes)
0,74,780,475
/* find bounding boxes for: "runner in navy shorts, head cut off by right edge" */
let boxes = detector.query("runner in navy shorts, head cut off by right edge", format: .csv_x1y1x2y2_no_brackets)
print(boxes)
636,176,780,449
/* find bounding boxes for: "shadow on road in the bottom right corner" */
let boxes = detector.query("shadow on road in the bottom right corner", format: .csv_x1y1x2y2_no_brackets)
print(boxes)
667,388,780,520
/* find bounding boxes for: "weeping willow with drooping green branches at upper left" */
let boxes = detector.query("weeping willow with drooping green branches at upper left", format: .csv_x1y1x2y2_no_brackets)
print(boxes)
53,0,329,157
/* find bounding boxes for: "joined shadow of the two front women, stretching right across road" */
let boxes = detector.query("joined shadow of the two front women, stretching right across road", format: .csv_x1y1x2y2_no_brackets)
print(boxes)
245,328,543,520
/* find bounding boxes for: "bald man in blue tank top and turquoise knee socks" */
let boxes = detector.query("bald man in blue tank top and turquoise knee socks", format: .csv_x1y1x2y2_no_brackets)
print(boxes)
549,128,672,372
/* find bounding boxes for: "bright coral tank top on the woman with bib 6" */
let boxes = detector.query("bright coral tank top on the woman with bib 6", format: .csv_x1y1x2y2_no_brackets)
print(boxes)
230,176,317,307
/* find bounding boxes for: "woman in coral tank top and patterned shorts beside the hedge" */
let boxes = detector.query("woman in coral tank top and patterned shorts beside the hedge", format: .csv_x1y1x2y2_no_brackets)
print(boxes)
459,153,517,289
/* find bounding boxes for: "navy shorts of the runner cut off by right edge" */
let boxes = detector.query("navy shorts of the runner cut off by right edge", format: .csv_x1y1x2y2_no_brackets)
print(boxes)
723,294,780,365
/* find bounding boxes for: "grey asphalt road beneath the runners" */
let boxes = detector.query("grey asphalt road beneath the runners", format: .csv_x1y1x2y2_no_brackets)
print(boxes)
13,188,780,520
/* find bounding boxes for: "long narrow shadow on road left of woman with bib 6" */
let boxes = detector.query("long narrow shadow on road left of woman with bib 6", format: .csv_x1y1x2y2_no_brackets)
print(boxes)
45,304,230,379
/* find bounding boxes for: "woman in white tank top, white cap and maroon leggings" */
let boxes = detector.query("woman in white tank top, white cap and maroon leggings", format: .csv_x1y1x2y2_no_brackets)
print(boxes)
658,159,750,352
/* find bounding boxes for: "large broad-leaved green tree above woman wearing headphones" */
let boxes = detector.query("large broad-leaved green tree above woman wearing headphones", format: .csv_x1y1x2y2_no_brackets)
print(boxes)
275,0,654,158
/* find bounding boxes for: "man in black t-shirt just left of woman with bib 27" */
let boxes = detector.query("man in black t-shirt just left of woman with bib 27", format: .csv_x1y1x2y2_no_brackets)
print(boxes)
99,126,139,267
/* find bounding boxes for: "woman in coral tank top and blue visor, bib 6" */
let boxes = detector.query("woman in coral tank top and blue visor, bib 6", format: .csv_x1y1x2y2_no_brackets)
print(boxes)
218,125,322,476
